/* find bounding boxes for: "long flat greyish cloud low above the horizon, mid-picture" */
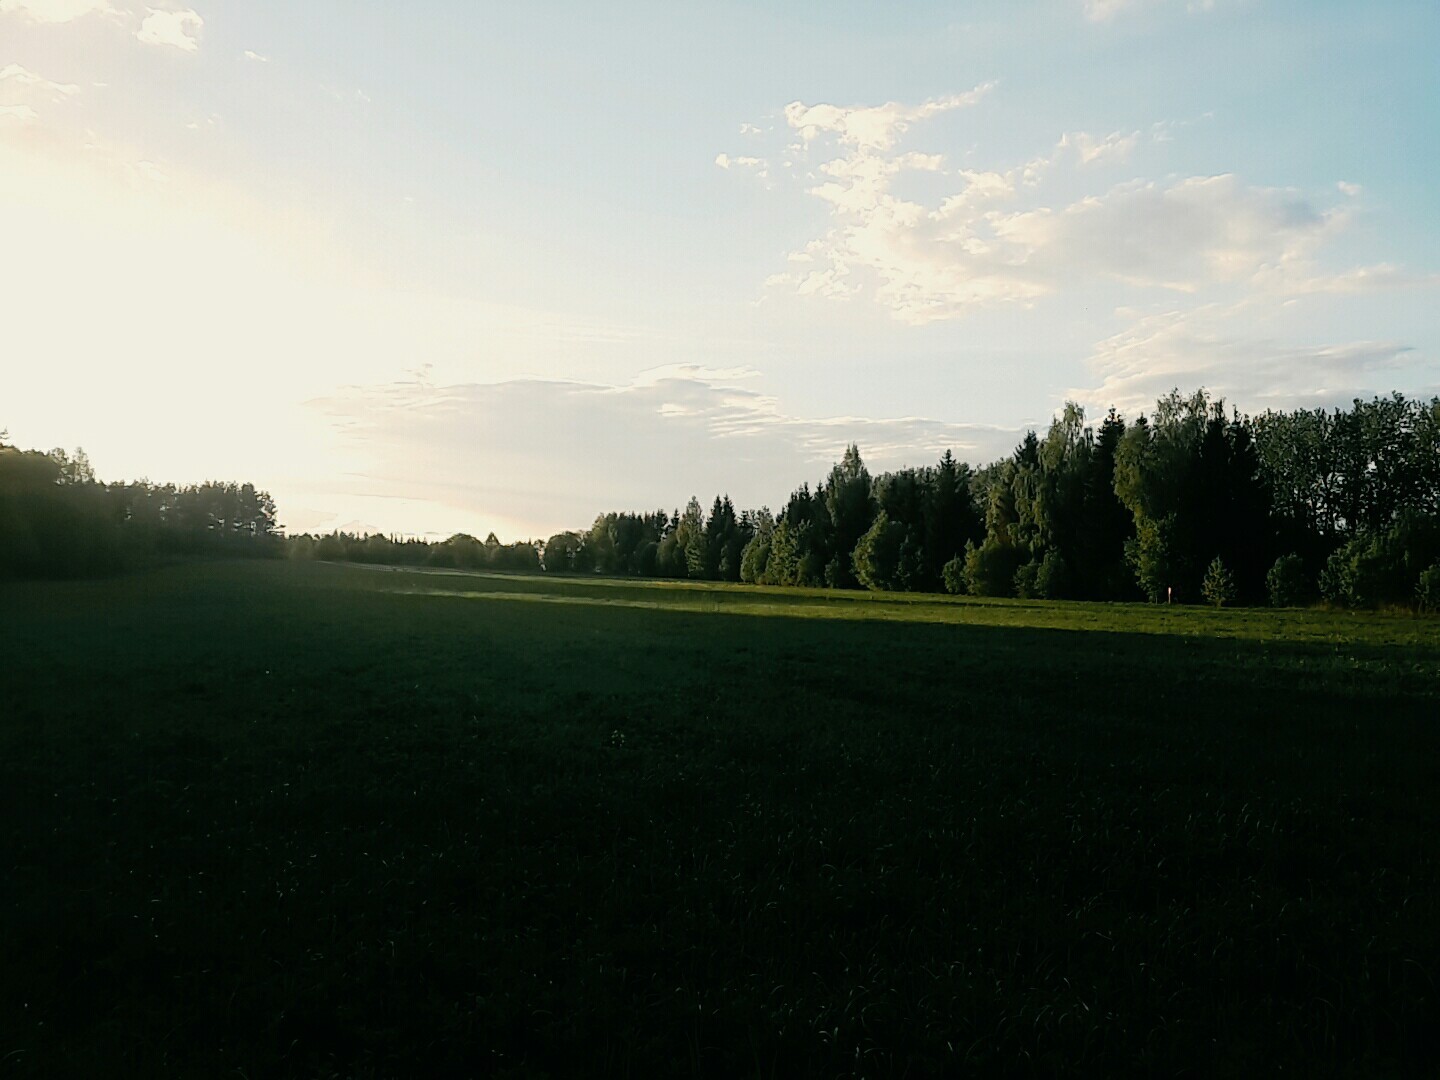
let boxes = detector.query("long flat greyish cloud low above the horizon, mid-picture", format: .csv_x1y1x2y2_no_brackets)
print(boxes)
311,364,1017,534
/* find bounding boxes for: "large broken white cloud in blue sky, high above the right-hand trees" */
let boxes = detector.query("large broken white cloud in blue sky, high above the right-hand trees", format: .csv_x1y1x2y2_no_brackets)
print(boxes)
737,86,1398,324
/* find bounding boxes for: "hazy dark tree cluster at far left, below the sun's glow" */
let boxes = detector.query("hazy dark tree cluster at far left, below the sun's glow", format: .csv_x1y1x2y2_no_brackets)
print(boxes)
0,442,281,577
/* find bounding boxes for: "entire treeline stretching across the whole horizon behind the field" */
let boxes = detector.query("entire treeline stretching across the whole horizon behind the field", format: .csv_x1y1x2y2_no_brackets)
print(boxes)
11,392,1440,609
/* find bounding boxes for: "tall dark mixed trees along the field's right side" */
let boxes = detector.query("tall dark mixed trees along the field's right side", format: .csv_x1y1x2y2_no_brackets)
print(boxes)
543,390,1440,609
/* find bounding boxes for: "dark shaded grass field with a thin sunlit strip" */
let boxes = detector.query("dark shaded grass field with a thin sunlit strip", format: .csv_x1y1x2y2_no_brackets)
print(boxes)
0,563,1440,1077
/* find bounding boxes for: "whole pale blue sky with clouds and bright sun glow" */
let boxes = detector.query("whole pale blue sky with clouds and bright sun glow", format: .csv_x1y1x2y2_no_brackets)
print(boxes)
0,0,1440,540
